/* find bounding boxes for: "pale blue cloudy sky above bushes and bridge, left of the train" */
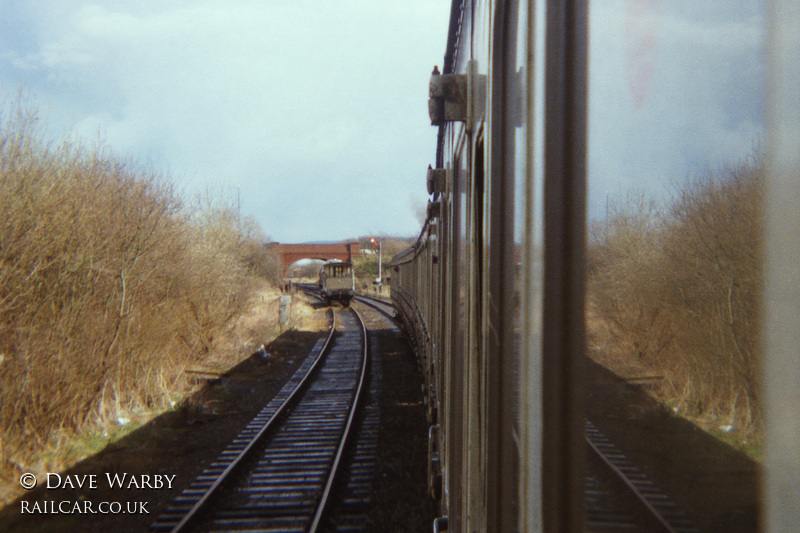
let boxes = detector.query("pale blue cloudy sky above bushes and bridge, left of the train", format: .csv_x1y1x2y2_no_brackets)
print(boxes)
0,0,450,242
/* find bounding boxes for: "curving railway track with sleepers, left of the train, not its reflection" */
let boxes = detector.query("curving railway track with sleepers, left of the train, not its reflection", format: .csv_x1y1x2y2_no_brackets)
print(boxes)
151,309,369,533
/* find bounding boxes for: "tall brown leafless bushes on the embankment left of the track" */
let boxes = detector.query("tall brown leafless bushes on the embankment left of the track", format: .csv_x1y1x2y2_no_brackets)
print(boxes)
0,96,277,486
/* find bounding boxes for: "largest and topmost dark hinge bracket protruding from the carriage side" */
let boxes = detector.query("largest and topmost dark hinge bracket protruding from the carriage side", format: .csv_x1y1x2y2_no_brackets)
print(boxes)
428,60,486,130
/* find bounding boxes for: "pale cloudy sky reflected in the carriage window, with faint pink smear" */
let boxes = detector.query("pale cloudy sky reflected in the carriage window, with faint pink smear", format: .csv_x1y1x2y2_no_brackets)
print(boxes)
588,0,765,218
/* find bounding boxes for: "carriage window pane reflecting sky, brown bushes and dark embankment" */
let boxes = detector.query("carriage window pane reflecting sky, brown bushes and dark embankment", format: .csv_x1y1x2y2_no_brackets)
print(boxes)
585,0,765,531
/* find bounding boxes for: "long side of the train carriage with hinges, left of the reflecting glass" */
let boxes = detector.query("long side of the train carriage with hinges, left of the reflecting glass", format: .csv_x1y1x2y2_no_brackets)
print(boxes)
392,1,585,531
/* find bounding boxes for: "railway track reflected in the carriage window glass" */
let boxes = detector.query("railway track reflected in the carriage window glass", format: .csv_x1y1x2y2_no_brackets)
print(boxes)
585,420,698,533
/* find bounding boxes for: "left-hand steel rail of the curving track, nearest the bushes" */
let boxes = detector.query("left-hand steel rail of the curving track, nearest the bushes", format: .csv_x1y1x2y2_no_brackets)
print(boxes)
170,311,336,533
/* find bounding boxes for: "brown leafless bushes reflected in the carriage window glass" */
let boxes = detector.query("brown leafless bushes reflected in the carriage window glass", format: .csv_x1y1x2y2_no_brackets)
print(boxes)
589,160,762,438
